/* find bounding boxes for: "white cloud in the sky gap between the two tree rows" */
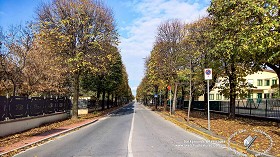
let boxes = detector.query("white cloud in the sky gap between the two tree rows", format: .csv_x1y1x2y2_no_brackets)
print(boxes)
120,0,208,94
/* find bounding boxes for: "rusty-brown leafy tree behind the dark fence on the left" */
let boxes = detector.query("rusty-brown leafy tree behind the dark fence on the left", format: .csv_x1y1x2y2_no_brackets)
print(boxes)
21,39,69,96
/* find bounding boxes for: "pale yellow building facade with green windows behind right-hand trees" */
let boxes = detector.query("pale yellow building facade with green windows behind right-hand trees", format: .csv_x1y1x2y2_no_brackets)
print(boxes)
199,70,279,101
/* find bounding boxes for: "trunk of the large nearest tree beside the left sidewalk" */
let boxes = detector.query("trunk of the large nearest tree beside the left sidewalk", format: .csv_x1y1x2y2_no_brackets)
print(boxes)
72,72,80,119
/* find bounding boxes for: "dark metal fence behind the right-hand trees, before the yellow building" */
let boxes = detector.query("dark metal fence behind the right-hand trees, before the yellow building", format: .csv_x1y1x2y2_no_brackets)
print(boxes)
183,99,280,119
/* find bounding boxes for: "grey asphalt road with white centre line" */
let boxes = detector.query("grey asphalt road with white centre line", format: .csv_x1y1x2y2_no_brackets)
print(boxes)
17,103,235,157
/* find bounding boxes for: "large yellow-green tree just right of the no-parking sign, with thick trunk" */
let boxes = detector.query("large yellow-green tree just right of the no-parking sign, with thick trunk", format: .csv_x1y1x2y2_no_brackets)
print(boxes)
208,0,259,117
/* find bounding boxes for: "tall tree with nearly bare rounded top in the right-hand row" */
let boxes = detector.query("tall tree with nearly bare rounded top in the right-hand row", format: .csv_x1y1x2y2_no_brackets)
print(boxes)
155,19,184,112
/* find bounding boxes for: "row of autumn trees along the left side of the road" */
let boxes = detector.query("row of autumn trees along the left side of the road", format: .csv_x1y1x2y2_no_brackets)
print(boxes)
0,0,133,118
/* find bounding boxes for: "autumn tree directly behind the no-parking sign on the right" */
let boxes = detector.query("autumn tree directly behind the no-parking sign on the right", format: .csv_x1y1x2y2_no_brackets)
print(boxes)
182,17,222,116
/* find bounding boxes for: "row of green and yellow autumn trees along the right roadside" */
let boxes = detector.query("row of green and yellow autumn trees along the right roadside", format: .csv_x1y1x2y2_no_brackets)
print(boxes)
137,0,280,117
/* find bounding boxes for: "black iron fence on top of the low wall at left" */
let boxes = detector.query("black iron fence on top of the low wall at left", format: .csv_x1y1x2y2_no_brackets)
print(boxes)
0,96,72,121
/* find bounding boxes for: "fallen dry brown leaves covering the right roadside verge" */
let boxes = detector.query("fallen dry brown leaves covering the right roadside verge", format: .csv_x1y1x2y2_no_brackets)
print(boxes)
165,110,280,156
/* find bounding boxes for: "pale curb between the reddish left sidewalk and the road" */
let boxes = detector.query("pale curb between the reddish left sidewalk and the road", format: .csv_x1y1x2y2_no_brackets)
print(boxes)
0,119,99,156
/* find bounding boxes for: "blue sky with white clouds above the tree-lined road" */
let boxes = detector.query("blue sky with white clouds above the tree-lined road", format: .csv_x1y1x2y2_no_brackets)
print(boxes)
0,0,210,95
